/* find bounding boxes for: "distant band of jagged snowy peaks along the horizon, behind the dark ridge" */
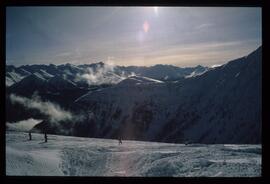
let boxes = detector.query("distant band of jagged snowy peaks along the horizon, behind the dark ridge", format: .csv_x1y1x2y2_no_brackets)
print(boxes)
6,62,208,87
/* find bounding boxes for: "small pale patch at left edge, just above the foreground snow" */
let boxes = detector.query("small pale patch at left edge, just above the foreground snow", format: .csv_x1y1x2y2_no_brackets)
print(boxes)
6,118,42,131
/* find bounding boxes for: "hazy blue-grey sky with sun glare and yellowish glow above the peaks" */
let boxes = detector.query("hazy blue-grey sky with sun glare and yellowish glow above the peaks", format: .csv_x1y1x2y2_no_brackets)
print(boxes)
6,6,262,67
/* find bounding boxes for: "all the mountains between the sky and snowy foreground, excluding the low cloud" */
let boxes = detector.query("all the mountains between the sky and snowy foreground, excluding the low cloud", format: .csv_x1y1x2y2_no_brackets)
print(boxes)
6,47,262,144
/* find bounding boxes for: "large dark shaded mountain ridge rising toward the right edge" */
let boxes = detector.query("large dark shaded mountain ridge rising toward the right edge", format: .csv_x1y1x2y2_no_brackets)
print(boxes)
71,48,261,143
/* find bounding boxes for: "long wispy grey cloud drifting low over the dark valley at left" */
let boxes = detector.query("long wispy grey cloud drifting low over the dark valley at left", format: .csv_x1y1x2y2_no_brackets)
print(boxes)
10,94,74,122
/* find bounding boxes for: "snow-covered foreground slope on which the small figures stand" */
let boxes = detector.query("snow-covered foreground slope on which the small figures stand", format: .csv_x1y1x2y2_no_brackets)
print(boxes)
6,132,261,177
